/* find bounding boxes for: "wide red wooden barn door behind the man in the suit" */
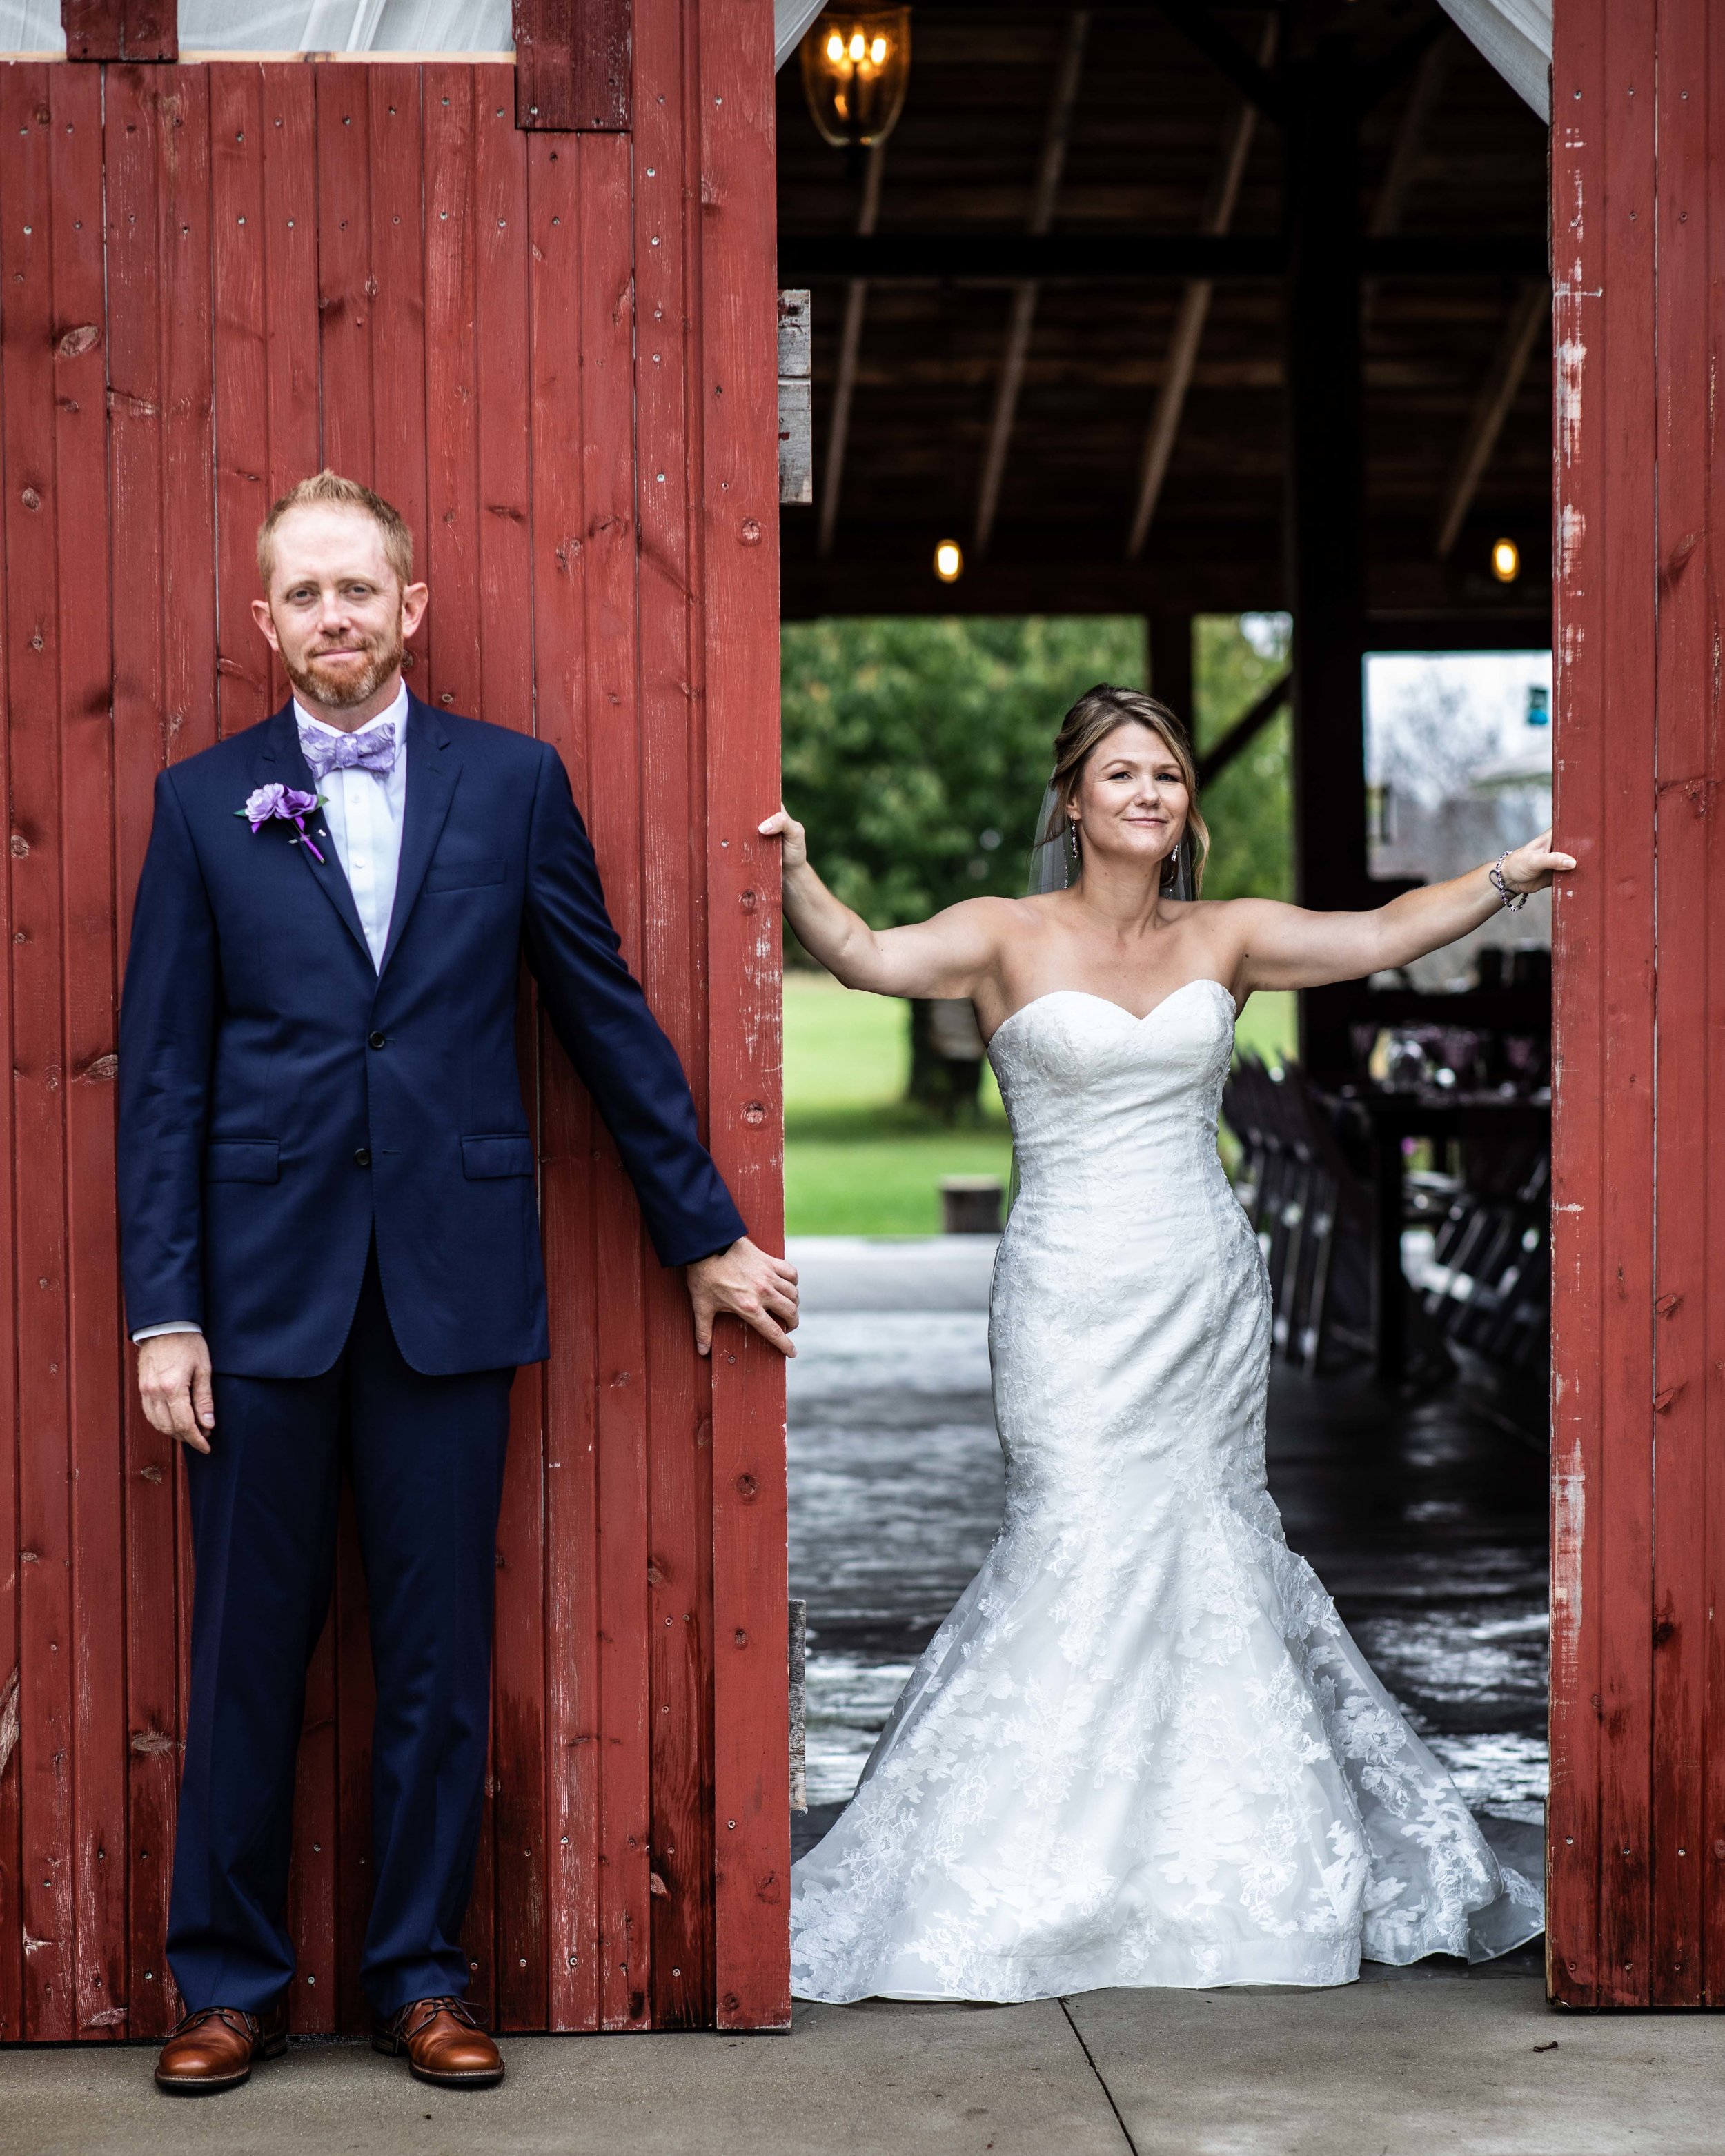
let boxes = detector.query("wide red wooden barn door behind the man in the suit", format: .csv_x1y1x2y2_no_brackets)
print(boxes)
0,0,789,2039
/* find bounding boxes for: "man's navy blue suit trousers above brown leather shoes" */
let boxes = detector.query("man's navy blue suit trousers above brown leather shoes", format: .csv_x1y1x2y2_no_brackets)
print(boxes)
168,1251,515,2014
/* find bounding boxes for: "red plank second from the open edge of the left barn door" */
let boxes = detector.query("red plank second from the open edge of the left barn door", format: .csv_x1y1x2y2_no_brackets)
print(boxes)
632,0,713,2029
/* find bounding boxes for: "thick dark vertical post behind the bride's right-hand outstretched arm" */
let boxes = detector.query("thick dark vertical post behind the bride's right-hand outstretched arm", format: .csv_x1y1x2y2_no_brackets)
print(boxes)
1285,37,1372,1071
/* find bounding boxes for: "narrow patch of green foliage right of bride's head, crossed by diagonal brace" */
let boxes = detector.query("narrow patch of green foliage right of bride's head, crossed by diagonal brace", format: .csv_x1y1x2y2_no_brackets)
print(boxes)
1192,615,1294,899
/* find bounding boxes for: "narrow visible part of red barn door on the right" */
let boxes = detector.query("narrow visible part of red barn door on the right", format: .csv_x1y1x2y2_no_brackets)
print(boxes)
1548,0,1725,2007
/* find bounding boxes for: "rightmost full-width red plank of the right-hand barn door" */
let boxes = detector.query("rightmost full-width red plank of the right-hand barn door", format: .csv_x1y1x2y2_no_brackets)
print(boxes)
1648,0,1719,2005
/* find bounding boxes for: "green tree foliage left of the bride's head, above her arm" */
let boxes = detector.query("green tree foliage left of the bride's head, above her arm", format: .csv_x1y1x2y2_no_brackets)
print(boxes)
782,617,1147,927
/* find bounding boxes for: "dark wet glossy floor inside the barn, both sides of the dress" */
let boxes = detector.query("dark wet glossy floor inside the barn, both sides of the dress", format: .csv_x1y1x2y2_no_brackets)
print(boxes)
789,1238,1546,1865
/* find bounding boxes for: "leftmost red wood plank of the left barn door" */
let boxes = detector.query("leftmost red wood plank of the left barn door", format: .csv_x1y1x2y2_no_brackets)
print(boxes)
0,67,78,2039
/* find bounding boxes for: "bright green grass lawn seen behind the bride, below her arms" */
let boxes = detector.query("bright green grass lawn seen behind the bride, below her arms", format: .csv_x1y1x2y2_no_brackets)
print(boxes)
785,972,1294,1236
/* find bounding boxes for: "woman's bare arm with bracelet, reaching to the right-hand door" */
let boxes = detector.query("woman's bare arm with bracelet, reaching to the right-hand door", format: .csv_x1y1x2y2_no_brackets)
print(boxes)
1229,830,1574,989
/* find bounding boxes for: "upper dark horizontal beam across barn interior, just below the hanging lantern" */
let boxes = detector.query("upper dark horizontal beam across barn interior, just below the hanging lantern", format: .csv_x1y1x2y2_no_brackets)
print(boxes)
778,230,1546,285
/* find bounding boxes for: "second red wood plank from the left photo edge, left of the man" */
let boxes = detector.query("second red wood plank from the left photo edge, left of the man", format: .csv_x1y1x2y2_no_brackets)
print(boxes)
48,69,127,2037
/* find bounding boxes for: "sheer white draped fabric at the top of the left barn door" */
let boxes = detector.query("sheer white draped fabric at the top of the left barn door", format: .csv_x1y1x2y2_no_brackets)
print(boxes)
0,0,826,67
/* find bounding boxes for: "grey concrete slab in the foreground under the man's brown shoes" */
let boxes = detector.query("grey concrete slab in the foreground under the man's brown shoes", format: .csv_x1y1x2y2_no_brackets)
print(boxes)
0,1977,1725,2156
